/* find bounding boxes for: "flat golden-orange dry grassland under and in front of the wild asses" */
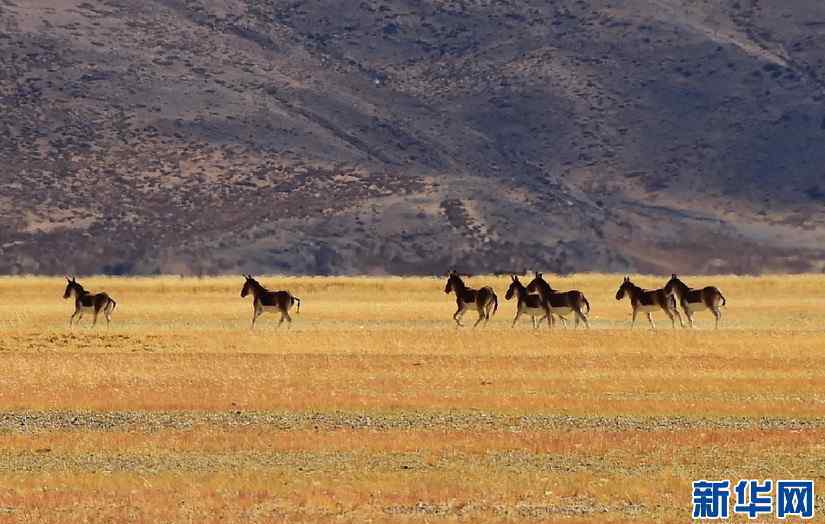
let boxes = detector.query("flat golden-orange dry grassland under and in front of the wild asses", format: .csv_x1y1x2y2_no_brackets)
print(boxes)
0,274,825,522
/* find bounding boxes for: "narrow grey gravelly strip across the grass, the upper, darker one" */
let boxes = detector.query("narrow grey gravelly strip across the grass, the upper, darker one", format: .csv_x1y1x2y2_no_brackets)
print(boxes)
0,411,825,433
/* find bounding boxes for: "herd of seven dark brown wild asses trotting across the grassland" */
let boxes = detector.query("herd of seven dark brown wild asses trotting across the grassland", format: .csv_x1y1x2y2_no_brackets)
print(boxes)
63,271,726,329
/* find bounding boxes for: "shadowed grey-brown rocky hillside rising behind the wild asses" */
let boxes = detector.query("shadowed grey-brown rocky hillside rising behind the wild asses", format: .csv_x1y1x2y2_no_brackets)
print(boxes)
0,0,825,274
